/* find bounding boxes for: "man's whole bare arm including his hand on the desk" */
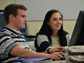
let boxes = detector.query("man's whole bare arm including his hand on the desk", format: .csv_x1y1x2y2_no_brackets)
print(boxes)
9,45,63,60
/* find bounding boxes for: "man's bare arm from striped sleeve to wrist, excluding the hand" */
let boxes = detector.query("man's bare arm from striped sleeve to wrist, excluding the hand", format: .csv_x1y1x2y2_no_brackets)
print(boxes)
10,45,47,58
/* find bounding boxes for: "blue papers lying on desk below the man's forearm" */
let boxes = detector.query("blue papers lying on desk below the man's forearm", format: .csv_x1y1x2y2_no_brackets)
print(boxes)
13,58,52,63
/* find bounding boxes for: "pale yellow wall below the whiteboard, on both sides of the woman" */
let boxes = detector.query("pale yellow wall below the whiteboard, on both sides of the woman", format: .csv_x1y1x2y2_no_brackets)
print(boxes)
27,20,76,35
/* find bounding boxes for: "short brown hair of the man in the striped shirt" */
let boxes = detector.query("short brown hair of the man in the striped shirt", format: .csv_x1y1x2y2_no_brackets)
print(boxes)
4,4,27,24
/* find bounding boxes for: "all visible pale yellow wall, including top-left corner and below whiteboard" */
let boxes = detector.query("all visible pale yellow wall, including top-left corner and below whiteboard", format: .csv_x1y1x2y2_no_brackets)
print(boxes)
0,0,76,35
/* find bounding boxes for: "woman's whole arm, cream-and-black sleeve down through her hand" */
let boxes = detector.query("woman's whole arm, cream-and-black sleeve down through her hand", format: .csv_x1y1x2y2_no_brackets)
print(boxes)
37,35,65,53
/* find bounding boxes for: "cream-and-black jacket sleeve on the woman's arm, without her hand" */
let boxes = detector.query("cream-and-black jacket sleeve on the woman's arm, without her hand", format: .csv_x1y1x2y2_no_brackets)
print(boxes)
35,35,50,52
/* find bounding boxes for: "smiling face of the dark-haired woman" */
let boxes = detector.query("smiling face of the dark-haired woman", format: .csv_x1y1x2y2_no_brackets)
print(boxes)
48,12,62,31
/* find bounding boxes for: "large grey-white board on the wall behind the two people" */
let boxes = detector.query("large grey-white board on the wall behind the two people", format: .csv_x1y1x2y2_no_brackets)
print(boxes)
15,0,84,20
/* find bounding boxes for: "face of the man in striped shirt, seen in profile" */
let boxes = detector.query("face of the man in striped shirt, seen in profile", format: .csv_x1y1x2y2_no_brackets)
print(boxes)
14,9,27,29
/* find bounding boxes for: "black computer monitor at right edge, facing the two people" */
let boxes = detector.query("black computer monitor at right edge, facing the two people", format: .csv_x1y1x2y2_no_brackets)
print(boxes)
69,11,84,46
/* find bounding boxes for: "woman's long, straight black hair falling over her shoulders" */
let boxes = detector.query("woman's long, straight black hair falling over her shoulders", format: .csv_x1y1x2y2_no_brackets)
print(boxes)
35,9,67,47
